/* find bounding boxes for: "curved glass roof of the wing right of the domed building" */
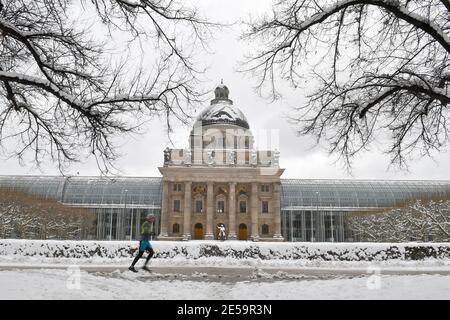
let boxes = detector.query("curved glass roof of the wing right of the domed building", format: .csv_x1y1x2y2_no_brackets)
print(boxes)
281,179,450,210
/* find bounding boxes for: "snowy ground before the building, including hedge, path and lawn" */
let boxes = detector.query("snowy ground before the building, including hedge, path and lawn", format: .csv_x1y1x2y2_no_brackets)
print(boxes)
0,240,450,300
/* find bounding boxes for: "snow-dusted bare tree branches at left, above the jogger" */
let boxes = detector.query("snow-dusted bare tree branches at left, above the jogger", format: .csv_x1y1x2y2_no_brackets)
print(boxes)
0,0,218,173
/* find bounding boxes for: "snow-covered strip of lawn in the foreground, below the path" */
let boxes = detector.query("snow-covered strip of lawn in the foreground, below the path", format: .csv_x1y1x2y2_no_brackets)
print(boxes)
0,269,450,300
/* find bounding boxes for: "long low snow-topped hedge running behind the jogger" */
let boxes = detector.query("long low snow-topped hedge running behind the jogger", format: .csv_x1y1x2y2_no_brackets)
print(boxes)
0,239,450,261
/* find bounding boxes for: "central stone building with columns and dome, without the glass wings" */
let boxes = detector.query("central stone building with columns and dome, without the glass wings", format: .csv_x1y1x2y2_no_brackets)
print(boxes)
159,85,284,241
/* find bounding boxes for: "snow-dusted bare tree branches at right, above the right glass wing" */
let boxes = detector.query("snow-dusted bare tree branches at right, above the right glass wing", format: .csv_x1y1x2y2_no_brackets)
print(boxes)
243,0,450,167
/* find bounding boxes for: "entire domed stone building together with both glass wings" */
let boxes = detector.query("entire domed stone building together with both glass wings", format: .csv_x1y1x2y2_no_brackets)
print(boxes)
0,84,450,242
